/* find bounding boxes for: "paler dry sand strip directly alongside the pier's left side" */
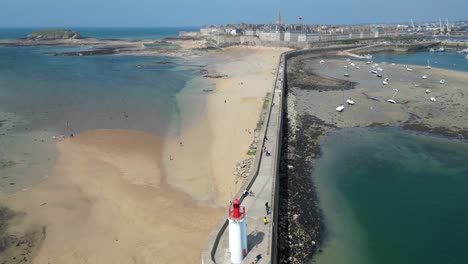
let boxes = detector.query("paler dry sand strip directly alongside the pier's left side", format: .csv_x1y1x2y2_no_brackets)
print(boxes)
163,47,285,206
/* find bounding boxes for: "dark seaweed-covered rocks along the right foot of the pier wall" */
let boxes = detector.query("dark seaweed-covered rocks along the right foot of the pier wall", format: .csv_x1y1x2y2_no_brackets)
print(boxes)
278,50,354,263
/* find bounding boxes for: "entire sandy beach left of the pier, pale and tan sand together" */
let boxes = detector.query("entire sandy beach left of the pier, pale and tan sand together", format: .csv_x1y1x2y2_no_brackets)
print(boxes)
0,48,283,263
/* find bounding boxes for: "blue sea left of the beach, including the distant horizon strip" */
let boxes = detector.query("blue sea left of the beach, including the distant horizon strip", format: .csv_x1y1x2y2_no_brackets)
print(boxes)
0,29,210,193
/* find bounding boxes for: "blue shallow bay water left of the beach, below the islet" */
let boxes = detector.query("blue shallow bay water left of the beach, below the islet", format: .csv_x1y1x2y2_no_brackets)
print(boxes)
0,47,205,135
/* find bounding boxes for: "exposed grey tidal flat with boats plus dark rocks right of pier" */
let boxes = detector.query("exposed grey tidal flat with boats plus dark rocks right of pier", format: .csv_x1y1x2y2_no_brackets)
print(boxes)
278,44,468,263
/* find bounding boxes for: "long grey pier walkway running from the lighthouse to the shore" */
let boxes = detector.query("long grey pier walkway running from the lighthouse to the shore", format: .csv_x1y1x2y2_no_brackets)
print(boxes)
202,54,285,264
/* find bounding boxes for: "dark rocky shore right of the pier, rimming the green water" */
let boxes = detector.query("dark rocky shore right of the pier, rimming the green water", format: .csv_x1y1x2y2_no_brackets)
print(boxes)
278,49,468,263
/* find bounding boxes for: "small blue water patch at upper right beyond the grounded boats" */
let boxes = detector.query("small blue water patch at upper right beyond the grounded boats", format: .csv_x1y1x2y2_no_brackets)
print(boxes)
372,51,468,72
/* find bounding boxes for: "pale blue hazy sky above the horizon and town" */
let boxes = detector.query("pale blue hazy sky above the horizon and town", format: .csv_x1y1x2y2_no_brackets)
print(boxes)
0,0,468,27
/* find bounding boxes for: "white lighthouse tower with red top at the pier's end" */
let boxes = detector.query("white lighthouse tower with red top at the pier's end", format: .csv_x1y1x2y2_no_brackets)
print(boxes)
228,199,247,264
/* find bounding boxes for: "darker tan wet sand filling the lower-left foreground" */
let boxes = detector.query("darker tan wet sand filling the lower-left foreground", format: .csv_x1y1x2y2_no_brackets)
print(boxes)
2,130,221,263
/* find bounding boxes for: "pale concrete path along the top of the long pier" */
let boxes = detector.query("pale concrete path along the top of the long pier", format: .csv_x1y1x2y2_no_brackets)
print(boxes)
215,60,284,264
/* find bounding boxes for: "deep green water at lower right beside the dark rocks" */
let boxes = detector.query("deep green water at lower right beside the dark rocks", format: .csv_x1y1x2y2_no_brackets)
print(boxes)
313,128,468,264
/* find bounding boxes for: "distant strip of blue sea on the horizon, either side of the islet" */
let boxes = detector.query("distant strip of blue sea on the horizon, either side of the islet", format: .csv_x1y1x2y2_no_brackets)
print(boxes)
0,27,199,39
